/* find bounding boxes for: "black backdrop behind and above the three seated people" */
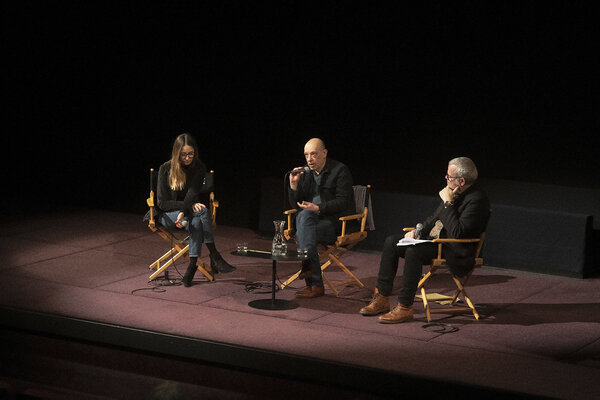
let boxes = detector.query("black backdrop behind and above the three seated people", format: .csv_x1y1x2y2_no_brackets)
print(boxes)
2,1,600,228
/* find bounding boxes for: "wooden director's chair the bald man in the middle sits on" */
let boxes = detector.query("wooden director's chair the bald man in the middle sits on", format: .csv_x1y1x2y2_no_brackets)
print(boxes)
281,185,372,296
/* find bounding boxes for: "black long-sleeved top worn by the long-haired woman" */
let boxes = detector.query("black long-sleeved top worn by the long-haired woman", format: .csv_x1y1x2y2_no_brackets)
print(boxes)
157,160,206,217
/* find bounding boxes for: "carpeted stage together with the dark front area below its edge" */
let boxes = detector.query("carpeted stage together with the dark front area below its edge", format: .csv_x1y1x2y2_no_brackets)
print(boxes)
0,210,600,399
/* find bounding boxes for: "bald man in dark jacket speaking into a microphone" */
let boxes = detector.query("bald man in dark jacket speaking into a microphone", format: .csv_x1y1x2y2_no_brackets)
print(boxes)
288,138,356,298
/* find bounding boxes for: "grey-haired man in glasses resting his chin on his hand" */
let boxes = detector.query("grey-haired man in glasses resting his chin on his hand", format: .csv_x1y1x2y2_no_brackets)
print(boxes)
360,157,490,324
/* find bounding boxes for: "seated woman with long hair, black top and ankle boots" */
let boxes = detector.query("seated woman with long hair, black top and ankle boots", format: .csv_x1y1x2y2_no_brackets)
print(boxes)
157,133,235,287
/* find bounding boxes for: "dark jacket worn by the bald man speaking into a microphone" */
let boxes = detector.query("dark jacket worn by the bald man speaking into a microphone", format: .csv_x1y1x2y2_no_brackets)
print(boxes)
288,158,356,224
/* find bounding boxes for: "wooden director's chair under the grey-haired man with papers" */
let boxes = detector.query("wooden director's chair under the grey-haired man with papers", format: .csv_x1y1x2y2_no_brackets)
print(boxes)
404,228,485,322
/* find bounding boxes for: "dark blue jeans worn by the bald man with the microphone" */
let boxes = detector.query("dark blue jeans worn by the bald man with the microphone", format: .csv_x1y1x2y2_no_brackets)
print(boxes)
296,210,337,286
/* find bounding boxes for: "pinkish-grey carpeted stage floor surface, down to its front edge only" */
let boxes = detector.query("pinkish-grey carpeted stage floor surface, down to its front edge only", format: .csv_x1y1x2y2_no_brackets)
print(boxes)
0,210,600,399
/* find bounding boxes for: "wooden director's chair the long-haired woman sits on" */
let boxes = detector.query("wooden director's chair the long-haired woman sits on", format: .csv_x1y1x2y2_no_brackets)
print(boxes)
146,168,219,281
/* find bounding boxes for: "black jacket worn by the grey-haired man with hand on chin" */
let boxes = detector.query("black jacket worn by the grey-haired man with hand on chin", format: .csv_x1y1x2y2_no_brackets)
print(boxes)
423,183,490,276
